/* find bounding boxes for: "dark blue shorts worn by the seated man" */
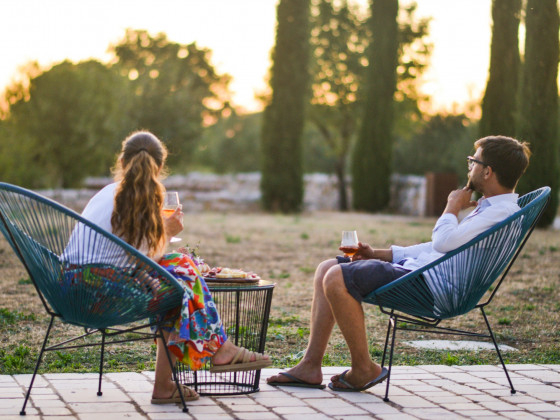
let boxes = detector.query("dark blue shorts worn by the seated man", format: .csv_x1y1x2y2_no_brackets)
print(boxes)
336,256,410,302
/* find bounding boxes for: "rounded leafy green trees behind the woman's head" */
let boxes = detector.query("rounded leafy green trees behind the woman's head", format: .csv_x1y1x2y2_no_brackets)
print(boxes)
0,30,229,188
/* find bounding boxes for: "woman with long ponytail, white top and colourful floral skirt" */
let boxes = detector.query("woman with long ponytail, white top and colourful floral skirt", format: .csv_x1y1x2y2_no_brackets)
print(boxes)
76,131,271,404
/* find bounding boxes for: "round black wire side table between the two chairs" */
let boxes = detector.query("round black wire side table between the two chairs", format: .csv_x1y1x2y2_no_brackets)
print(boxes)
177,280,275,395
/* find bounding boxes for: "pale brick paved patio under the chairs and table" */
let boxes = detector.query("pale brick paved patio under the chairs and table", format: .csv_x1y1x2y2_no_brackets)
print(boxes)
0,365,560,420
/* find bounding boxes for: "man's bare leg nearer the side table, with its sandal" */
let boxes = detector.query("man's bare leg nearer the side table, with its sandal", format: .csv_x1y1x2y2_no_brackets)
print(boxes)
267,260,338,384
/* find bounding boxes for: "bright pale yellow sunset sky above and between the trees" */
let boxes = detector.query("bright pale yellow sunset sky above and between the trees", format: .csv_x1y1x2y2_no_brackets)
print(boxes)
0,0,491,111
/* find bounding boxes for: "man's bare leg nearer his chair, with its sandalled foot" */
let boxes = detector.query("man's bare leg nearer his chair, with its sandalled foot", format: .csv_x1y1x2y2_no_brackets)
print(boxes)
323,265,381,388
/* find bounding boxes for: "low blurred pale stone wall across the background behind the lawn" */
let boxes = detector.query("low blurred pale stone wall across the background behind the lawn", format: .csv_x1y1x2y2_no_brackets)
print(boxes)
41,172,425,216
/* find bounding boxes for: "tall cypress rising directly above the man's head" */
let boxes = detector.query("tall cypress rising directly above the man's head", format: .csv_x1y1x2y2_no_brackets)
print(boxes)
479,0,521,137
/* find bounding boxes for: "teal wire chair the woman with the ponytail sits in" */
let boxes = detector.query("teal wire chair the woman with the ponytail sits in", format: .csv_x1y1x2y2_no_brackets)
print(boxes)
0,183,188,415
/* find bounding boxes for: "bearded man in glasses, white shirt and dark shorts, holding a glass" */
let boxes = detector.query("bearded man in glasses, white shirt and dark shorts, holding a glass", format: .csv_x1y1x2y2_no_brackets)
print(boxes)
267,136,531,392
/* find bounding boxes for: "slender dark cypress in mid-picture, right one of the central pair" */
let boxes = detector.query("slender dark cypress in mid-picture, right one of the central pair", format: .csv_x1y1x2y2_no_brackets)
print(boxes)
352,0,399,211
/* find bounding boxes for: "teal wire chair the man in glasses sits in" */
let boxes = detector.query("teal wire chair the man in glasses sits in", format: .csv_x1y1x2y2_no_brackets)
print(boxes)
364,187,550,401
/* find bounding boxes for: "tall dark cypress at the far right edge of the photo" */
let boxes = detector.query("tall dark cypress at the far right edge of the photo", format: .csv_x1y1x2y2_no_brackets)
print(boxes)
518,0,560,226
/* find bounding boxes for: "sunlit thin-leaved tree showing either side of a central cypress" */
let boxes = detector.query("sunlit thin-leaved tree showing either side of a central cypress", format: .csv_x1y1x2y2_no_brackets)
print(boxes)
309,0,430,210
